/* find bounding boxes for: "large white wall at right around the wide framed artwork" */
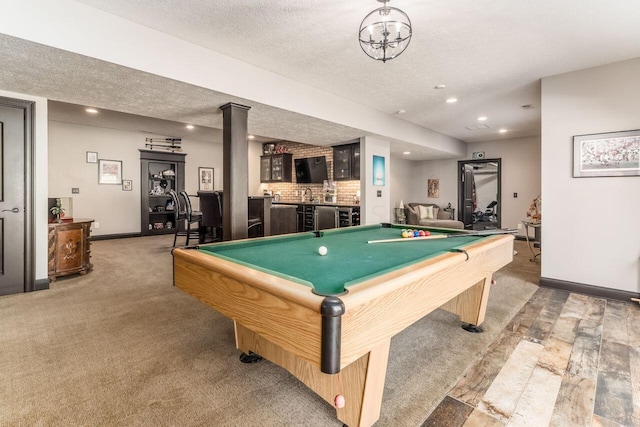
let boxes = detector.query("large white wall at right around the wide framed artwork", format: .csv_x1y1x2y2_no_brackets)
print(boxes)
542,58,640,292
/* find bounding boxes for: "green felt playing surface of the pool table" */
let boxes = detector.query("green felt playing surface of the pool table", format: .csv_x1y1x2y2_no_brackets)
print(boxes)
199,224,483,295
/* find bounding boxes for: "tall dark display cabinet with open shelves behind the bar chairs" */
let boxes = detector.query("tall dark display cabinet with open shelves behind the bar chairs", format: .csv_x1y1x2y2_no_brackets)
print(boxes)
140,150,186,236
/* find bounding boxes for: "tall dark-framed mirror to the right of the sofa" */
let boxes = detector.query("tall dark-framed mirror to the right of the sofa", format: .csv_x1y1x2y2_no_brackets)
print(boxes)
458,159,502,230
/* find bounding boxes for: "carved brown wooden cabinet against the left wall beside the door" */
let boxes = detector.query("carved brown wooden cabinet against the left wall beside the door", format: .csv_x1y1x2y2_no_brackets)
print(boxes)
49,219,93,281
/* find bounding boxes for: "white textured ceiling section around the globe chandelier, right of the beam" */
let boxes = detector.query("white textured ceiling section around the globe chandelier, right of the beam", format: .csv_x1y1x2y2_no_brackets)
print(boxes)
72,0,640,141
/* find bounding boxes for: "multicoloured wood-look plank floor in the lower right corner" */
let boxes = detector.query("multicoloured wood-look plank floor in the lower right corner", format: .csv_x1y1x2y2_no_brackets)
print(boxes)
423,288,640,427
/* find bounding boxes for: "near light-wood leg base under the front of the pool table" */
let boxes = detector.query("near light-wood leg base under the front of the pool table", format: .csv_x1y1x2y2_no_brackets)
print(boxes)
235,322,391,427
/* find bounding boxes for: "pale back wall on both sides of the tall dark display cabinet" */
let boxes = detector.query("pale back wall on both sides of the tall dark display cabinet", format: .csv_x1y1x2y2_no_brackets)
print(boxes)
45,121,222,236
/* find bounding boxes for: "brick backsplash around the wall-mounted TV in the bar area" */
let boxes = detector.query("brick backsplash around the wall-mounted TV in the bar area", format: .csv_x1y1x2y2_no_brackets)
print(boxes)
262,141,360,205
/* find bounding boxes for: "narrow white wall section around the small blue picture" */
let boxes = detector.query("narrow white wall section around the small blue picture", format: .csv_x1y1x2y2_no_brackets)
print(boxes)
360,136,393,225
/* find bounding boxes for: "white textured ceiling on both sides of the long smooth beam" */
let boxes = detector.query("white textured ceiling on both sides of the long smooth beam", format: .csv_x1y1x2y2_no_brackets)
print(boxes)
0,0,640,158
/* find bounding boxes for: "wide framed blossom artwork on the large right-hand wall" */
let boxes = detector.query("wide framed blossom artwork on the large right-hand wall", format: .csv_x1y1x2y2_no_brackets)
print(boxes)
573,130,640,178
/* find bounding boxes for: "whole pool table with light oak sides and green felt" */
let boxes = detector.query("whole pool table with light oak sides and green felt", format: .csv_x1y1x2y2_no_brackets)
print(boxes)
173,224,513,427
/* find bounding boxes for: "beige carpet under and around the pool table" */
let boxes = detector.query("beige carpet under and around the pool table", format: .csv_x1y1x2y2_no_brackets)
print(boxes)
0,236,539,426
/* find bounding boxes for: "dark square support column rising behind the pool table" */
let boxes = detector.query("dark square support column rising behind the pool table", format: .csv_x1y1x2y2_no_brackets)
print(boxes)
220,102,251,240
